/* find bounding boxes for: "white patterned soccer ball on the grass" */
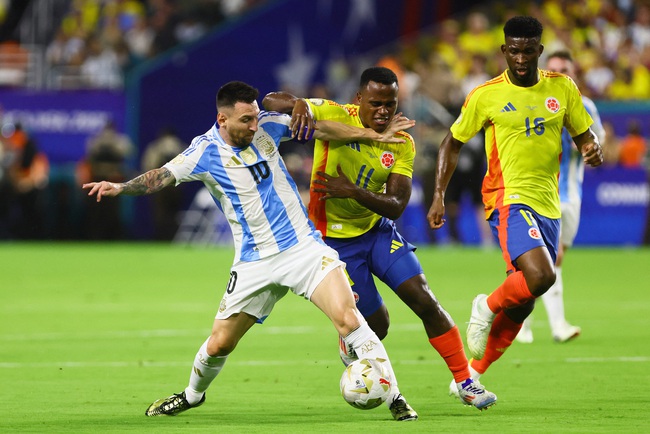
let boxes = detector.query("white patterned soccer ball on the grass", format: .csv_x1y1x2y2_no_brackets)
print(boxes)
340,359,392,410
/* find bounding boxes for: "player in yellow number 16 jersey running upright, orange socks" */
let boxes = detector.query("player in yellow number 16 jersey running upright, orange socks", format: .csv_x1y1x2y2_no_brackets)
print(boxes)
427,16,603,390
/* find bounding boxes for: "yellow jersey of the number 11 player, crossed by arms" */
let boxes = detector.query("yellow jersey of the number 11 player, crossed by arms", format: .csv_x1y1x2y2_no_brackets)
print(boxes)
307,98,415,238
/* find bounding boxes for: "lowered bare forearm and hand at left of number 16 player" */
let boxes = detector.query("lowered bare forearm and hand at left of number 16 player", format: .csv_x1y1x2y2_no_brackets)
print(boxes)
427,131,464,229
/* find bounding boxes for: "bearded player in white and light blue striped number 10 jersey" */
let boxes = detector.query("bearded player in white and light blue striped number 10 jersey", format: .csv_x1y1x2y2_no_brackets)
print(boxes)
83,81,417,420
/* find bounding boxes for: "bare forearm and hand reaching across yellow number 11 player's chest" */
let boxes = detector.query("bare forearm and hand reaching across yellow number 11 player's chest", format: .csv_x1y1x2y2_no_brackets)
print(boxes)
314,113,415,143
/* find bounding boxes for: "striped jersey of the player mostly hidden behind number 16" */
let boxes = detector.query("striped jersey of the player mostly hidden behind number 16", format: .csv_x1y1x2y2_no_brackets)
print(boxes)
558,96,605,204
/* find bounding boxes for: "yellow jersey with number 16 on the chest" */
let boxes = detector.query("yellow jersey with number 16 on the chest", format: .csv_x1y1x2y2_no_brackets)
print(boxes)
450,70,593,218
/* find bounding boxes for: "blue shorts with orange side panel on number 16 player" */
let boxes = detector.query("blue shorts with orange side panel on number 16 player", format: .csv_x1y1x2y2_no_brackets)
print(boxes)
488,204,560,272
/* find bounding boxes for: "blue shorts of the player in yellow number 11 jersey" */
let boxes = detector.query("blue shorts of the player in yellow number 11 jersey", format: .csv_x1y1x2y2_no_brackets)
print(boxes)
325,218,423,317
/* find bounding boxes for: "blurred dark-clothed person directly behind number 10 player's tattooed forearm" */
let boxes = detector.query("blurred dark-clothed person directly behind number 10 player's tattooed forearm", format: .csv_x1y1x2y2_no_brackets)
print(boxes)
142,128,187,240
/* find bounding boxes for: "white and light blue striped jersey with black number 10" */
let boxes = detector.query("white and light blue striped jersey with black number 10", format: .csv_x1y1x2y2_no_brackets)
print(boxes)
164,111,321,263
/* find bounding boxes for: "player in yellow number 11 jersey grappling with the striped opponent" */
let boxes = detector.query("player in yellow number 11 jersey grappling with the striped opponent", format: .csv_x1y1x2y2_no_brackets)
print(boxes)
263,67,497,420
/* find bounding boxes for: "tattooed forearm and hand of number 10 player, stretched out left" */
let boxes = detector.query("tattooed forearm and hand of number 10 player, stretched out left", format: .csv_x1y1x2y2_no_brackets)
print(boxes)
82,167,176,202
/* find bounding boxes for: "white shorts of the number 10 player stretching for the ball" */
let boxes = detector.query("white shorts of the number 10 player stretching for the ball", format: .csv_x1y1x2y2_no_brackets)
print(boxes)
216,237,345,323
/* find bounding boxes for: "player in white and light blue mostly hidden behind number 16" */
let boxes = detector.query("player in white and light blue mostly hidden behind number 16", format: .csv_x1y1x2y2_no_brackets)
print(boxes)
517,50,605,343
